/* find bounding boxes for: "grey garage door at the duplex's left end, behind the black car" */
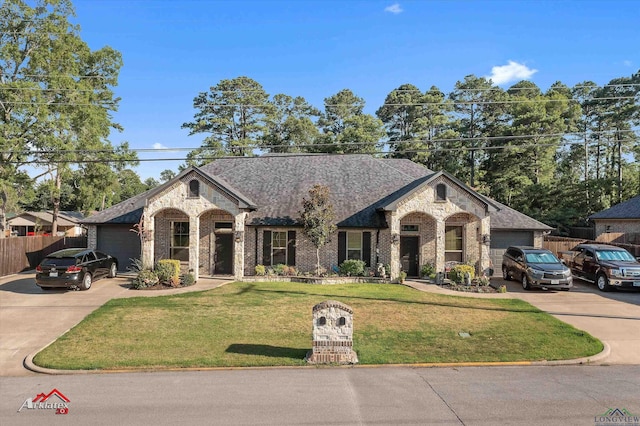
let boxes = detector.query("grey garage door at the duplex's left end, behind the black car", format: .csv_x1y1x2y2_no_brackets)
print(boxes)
97,224,141,272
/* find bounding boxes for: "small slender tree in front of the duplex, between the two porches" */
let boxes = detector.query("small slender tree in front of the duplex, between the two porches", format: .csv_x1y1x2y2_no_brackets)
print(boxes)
299,184,337,275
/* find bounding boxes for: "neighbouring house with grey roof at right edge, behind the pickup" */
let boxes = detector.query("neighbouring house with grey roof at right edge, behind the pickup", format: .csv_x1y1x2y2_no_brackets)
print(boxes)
589,195,640,244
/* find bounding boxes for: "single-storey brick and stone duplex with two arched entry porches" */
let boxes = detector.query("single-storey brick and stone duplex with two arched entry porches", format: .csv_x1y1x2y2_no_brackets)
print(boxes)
83,154,552,279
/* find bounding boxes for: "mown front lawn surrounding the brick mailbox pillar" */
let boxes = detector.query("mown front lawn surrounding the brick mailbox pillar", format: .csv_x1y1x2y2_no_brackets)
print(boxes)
34,283,603,369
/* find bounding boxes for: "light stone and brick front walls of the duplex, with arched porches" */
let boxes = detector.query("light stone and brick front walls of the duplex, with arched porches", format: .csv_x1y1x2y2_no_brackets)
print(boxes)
139,168,490,279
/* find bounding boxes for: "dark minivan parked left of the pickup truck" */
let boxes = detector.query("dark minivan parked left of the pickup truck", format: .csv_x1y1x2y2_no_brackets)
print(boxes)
502,246,573,291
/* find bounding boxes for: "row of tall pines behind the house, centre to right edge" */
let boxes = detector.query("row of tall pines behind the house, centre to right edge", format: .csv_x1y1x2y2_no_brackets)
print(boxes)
183,71,640,228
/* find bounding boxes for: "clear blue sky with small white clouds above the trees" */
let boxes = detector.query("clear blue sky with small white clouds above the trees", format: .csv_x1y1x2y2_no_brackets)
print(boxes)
74,0,640,180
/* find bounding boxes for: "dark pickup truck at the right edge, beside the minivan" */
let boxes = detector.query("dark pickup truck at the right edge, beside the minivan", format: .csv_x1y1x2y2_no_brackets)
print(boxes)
558,244,640,291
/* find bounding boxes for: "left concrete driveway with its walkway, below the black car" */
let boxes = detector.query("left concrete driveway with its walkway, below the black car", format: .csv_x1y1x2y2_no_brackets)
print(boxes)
0,272,229,376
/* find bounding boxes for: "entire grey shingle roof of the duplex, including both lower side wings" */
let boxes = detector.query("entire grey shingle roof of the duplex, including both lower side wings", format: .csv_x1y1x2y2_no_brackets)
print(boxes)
83,154,552,230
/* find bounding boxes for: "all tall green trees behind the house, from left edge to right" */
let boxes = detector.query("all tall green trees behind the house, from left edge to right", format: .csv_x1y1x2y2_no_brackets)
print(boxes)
0,0,640,235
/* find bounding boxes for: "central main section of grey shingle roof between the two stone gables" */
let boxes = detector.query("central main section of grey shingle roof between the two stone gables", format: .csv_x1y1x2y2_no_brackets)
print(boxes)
201,154,433,227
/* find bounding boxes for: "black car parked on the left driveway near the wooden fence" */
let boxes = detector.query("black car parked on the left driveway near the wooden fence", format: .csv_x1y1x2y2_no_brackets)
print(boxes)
36,248,118,290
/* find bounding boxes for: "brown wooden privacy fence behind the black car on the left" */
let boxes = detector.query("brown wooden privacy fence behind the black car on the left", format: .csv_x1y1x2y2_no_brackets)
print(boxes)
0,236,87,277
